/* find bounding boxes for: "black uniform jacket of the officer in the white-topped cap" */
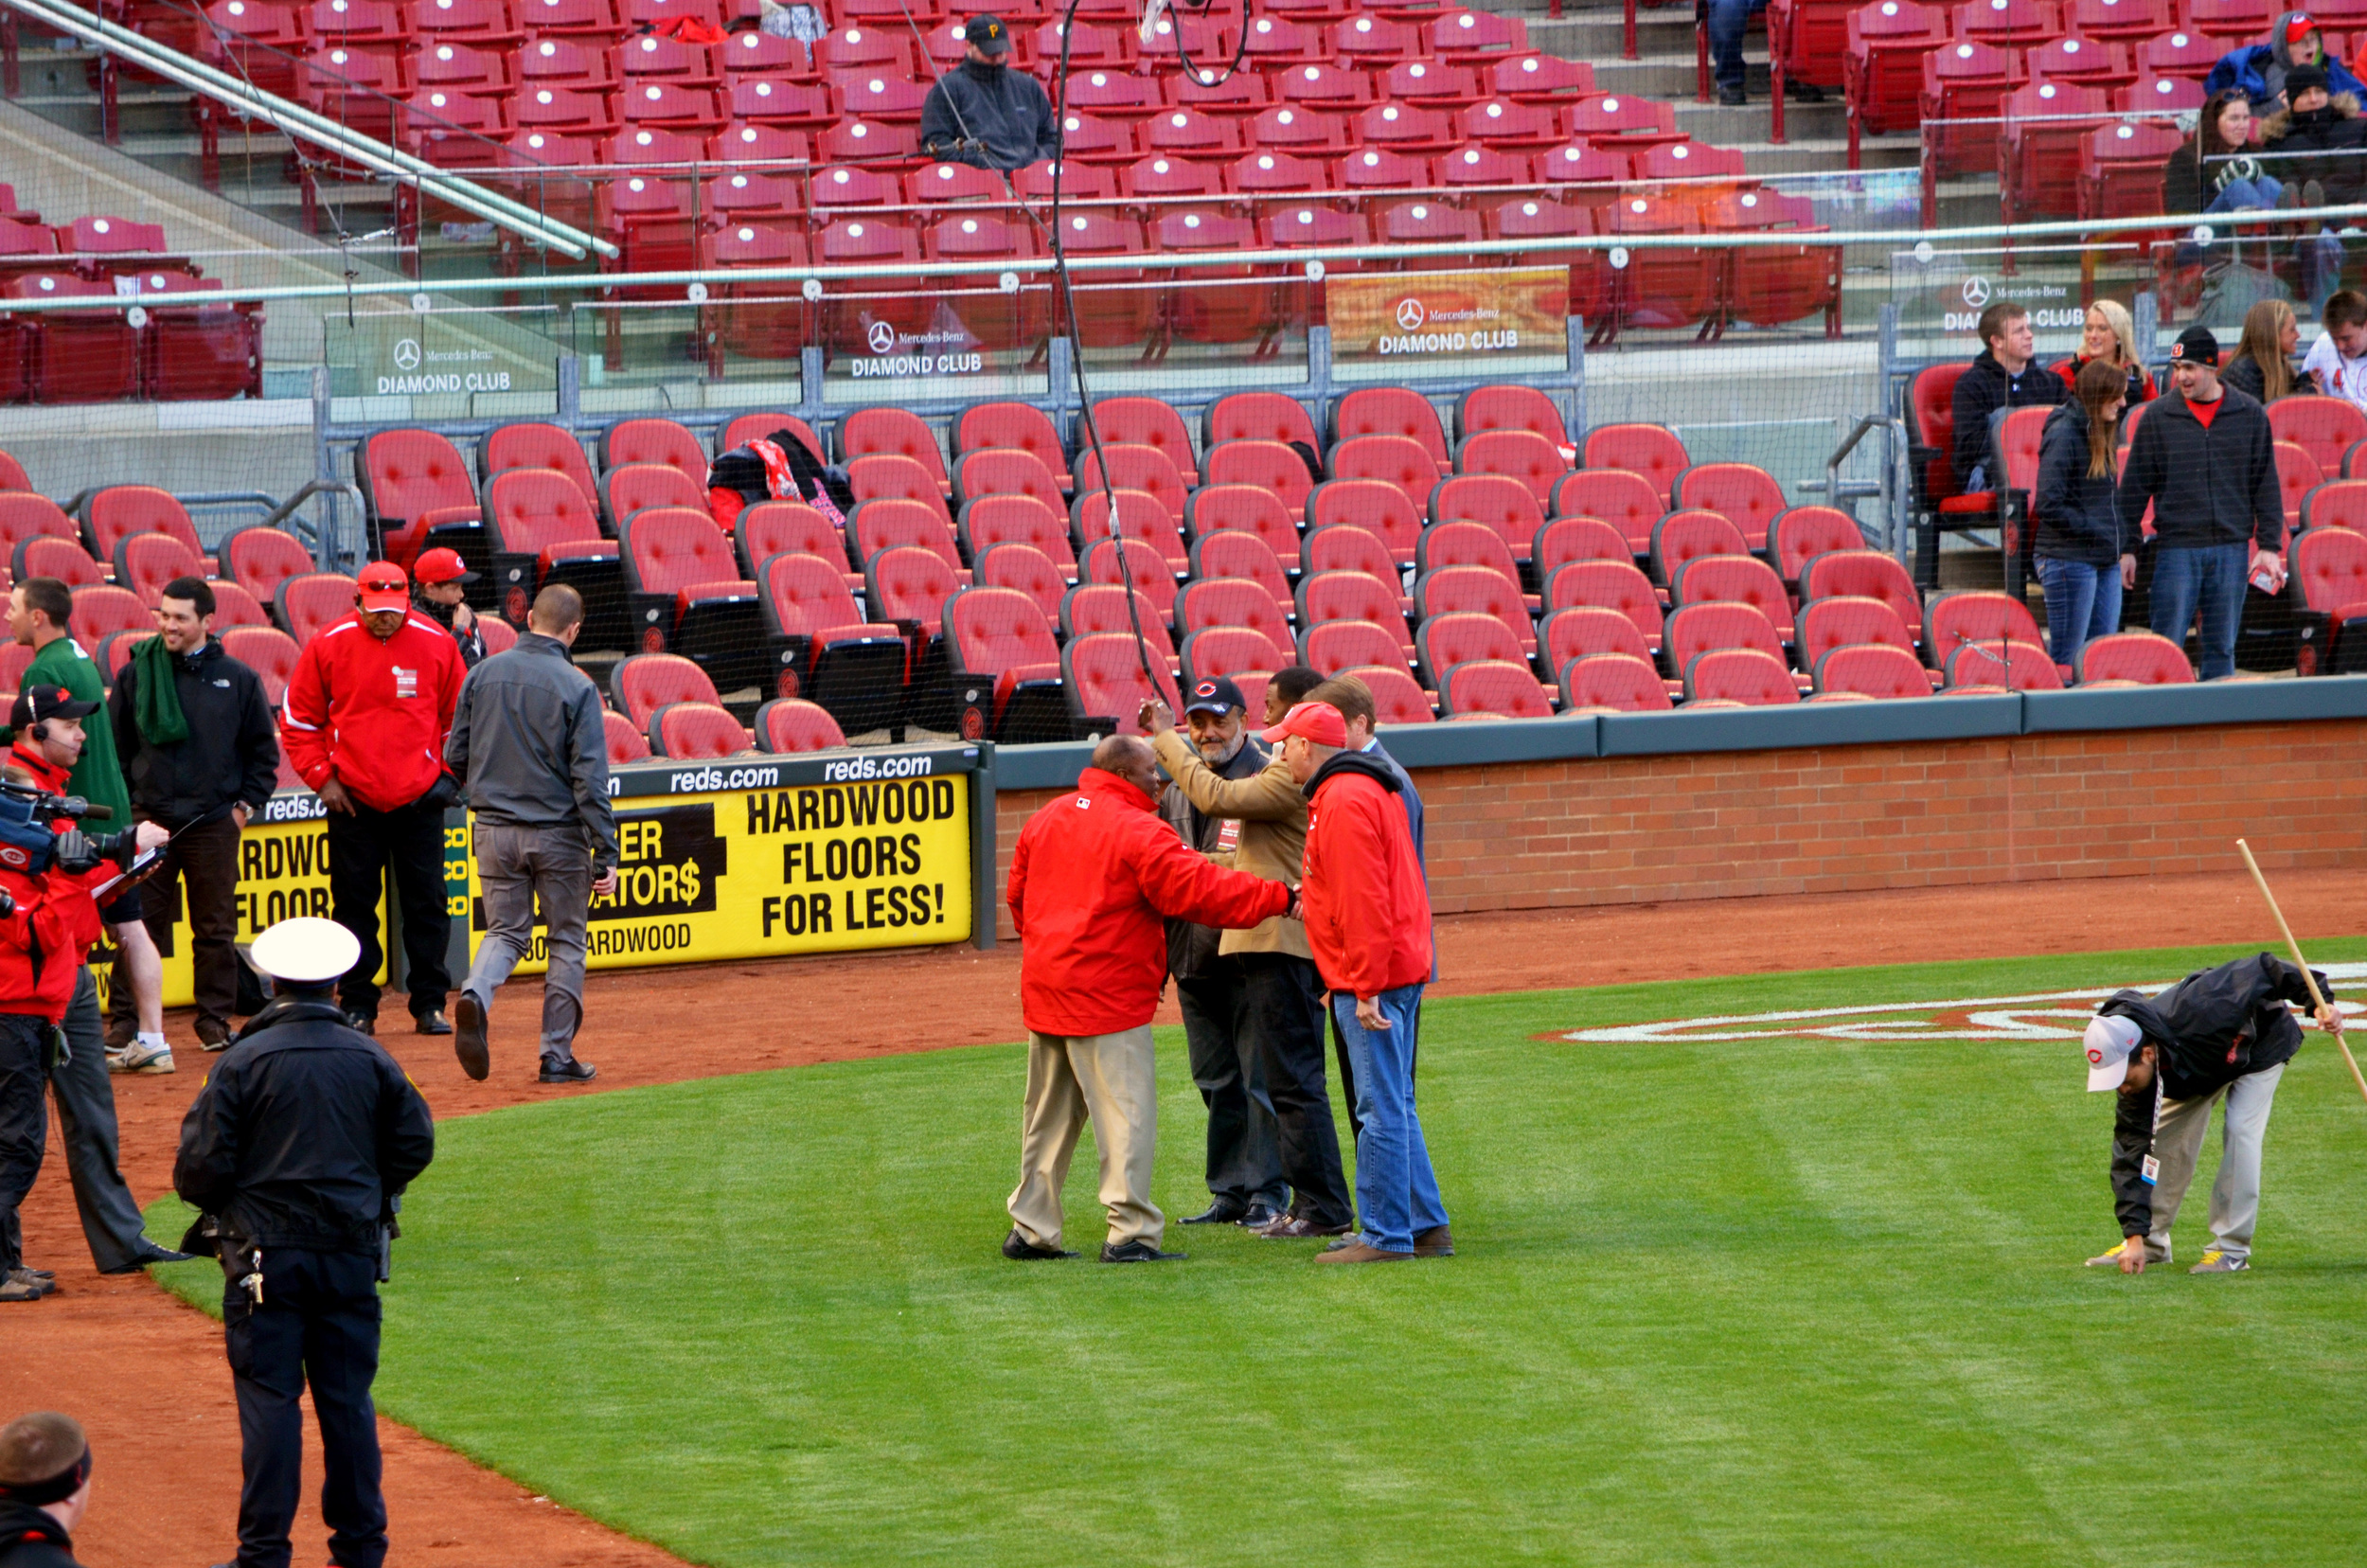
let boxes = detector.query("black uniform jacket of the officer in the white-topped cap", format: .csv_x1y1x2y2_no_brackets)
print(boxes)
173,997,436,1253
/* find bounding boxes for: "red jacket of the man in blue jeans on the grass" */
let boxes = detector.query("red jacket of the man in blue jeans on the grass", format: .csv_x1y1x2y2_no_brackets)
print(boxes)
1300,751,1430,997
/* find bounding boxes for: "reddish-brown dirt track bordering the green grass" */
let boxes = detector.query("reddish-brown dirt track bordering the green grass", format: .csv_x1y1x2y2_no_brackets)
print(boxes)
0,872,2362,1568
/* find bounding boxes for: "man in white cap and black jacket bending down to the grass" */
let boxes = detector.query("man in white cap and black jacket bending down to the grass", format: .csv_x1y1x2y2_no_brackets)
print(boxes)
2081,953,2341,1274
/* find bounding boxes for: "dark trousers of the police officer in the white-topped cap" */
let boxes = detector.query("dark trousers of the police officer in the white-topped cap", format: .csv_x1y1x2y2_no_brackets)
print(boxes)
222,1248,386,1568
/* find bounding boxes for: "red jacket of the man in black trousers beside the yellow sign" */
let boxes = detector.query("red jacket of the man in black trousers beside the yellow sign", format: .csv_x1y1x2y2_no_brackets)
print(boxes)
279,611,469,811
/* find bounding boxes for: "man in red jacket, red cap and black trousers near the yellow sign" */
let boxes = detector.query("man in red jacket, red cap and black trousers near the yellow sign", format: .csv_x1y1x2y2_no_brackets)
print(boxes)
279,561,469,1035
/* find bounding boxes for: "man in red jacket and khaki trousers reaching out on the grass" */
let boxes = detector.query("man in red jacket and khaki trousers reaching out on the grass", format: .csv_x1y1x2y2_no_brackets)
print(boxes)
1004,734,1297,1262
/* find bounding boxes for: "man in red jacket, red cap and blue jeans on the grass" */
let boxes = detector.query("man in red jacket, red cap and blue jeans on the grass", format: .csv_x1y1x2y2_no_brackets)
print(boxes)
1264,704,1456,1262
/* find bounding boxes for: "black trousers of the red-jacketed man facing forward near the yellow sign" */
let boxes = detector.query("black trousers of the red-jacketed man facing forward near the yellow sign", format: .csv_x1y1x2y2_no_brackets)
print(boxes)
329,801,453,1019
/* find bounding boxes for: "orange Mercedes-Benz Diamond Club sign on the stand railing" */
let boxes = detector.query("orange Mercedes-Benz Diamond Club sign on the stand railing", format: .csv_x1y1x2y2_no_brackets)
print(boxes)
1324,268,1570,365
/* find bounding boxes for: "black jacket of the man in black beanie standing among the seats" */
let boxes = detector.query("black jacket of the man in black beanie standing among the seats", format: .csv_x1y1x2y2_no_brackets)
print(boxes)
2121,391,2285,549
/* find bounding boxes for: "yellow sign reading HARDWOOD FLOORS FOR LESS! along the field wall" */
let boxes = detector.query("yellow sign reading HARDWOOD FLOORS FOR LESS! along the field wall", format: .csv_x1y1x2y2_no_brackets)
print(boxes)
469,775,970,971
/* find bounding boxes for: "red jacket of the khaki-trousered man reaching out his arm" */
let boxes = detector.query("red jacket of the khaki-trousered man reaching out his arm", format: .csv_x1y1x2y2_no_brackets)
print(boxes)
1011,767,1290,1035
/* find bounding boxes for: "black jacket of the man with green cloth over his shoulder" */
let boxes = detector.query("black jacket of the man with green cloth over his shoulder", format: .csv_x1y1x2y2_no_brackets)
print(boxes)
107,637,279,827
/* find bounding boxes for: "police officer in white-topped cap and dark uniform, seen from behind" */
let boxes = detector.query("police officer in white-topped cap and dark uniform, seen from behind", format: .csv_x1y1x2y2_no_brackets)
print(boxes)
173,919,436,1568
